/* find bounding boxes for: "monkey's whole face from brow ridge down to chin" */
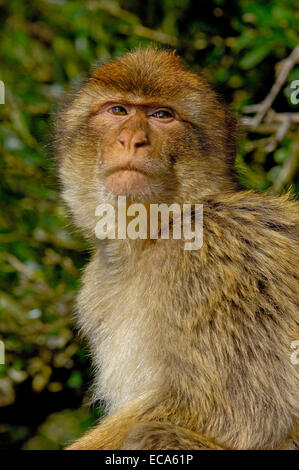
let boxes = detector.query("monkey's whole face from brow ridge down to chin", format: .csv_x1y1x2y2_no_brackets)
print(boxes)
89,99,190,202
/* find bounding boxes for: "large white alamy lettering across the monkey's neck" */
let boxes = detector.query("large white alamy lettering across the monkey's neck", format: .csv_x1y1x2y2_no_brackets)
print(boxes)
95,196,203,250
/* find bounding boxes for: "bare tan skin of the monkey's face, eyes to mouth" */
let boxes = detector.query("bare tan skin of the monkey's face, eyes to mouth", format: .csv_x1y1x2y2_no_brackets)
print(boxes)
91,101,184,198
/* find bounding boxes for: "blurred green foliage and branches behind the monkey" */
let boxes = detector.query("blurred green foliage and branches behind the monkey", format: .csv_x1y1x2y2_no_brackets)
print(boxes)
0,0,299,449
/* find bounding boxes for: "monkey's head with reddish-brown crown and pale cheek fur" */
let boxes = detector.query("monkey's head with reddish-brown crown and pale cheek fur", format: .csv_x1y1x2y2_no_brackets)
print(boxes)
56,48,235,235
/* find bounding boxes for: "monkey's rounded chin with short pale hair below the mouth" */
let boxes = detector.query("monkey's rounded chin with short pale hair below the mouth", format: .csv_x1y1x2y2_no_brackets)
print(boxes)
105,170,152,201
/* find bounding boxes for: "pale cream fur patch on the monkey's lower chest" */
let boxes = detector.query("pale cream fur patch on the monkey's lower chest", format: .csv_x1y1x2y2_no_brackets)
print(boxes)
97,288,161,411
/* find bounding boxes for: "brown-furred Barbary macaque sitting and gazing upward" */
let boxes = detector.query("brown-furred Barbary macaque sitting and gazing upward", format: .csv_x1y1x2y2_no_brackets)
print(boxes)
55,47,299,450
